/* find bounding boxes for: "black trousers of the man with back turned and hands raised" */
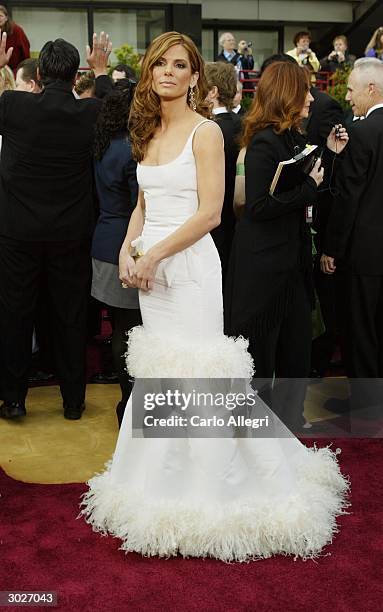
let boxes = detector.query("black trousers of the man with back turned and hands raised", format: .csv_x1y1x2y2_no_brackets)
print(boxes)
0,236,91,405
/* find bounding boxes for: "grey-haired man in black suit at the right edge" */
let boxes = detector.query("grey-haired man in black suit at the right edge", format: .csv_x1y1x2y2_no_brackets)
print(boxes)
321,58,383,408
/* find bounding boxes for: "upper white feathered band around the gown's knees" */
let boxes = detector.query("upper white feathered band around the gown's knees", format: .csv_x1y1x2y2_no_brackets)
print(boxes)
125,326,254,380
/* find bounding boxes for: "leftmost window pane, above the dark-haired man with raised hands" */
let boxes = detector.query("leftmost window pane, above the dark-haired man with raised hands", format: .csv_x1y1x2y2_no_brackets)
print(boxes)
12,7,88,66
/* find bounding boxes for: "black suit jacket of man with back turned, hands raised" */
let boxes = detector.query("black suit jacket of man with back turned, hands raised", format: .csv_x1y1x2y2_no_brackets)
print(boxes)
0,81,106,241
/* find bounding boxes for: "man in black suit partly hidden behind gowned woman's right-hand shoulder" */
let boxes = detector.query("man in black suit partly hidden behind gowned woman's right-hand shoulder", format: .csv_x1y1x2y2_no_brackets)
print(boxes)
205,62,242,285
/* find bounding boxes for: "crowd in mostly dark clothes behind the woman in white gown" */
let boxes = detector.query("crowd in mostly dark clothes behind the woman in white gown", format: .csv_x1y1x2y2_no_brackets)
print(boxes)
0,19,383,428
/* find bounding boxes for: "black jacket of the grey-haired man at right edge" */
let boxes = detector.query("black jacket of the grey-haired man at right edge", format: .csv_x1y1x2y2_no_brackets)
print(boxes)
324,108,383,275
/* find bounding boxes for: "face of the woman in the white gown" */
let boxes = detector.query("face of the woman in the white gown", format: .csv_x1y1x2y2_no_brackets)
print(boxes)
152,45,198,100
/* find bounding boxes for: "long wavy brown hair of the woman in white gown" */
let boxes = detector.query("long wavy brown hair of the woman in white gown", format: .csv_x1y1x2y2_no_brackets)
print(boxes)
129,32,210,161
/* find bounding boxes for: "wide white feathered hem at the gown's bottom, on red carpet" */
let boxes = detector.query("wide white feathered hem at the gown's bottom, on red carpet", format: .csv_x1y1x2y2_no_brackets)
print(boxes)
81,448,349,562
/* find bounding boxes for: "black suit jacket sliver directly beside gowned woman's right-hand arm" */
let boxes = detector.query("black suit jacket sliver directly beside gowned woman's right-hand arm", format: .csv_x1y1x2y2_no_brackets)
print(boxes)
211,112,242,275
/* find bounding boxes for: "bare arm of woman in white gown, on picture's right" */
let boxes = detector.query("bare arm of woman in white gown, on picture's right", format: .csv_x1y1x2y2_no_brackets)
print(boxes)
133,123,225,290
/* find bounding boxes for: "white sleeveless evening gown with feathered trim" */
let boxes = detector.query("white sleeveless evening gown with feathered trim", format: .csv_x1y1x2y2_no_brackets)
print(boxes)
82,122,348,561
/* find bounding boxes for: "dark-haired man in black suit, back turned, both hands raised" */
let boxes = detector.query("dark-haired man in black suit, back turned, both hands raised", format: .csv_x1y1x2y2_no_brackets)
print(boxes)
0,34,111,419
